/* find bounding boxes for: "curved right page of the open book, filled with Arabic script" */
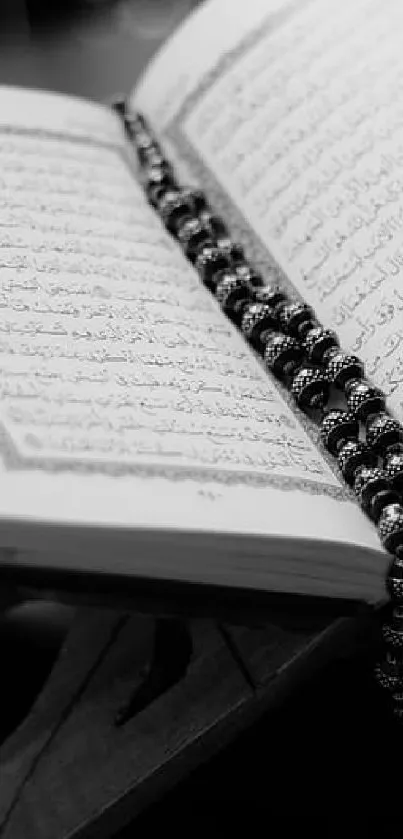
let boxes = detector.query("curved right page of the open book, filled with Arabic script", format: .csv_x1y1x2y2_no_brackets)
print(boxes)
133,0,403,419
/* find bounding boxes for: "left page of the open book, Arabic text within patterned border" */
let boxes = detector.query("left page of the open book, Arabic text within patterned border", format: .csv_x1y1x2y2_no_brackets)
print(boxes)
0,89,377,592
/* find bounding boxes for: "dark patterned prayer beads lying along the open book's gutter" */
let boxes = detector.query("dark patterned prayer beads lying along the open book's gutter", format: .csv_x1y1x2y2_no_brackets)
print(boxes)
121,105,403,722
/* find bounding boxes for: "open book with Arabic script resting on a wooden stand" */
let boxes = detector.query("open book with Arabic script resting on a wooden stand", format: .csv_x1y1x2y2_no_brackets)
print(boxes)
0,0,403,603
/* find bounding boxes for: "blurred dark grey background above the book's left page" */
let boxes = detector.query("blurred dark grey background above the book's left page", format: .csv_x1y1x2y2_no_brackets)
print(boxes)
0,0,200,100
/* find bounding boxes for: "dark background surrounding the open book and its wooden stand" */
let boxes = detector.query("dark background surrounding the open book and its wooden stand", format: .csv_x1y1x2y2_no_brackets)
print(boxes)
0,0,403,839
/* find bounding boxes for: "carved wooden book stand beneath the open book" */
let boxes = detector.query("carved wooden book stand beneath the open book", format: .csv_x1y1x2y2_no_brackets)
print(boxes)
0,596,370,839
